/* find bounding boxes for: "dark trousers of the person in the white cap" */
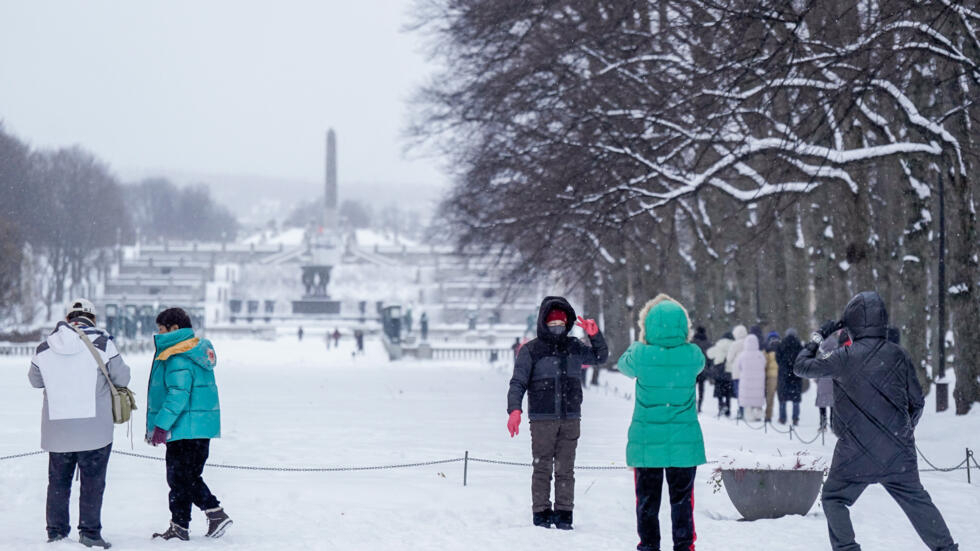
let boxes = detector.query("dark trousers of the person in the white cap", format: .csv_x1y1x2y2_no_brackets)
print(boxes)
47,444,112,539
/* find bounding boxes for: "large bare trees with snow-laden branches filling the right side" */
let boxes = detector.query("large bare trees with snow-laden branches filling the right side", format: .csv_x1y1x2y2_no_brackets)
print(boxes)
412,0,980,413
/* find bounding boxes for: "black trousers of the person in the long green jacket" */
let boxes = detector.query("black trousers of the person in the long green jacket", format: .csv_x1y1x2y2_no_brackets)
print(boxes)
633,467,698,551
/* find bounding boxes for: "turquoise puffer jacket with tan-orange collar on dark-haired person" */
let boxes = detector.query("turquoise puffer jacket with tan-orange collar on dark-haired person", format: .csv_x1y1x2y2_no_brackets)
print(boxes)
146,329,221,442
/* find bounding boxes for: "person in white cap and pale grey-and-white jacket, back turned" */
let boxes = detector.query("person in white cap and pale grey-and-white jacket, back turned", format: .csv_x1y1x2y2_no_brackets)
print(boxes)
28,298,129,549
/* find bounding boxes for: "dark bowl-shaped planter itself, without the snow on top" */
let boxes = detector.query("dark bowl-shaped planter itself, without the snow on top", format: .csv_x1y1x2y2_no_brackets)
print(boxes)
721,469,823,520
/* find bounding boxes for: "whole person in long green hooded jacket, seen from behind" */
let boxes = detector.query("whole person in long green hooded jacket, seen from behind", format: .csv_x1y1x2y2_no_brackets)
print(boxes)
617,295,706,551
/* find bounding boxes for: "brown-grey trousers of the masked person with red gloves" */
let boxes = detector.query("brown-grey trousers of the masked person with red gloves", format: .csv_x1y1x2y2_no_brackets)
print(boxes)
531,419,581,513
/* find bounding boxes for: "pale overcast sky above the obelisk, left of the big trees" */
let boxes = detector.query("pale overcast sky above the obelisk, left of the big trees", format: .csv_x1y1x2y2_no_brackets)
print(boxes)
0,0,446,196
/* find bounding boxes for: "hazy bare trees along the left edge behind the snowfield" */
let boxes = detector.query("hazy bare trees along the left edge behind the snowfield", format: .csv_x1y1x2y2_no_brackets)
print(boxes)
0,125,238,322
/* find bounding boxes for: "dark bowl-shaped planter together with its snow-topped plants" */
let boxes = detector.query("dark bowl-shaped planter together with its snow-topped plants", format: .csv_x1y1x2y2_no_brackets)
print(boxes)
711,452,827,520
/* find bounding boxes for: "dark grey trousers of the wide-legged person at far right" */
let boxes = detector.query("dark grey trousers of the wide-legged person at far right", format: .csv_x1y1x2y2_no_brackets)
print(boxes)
822,476,959,551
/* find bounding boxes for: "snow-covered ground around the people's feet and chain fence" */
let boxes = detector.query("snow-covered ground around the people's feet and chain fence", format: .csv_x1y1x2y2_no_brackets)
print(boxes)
0,339,980,551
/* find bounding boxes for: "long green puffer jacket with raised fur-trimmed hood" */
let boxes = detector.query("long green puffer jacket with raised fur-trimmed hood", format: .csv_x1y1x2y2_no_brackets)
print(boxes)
617,295,705,468
